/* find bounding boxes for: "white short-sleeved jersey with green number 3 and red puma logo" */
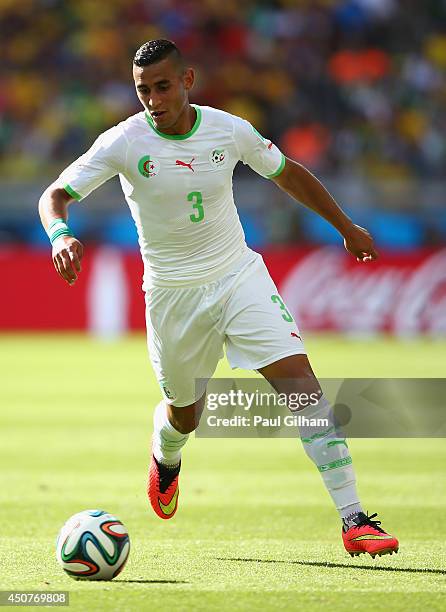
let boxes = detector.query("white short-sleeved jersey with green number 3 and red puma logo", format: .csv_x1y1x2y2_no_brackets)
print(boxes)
57,105,285,289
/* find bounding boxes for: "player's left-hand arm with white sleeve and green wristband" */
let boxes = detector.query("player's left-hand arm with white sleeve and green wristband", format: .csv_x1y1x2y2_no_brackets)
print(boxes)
39,126,122,285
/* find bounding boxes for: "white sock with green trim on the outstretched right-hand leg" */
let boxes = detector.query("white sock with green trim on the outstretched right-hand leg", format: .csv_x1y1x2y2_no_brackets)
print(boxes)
296,396,362,519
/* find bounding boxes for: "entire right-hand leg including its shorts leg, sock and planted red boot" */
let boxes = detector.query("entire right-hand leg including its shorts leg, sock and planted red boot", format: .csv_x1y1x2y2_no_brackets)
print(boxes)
224,256,398,555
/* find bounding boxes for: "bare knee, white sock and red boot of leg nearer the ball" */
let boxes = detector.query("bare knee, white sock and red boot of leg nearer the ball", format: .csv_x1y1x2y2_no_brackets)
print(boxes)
147,395,205,519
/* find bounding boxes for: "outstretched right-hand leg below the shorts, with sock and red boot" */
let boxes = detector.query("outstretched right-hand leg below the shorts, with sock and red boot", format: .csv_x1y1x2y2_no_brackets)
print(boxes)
258,355,399,557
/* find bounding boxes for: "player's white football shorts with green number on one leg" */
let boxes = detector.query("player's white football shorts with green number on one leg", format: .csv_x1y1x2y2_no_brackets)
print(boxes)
146,250,305,406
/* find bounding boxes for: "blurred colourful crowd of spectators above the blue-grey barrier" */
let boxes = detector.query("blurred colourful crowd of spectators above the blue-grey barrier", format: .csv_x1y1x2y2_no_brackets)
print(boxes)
0,0,446,178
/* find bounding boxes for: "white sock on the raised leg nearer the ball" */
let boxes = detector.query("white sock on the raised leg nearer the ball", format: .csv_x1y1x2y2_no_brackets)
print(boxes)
152,401,189,467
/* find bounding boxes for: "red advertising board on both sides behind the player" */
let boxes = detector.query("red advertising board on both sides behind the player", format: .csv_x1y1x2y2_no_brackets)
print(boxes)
0,247,446,336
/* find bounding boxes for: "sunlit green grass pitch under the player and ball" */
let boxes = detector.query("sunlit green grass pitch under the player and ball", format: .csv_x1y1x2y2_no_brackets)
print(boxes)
0,335,446,611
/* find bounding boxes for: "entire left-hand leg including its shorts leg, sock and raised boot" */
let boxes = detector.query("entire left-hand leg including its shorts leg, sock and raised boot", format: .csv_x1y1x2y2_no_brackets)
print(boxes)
146,285,223,519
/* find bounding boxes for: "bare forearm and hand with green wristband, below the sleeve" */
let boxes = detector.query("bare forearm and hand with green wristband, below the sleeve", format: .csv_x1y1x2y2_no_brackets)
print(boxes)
39,184,84,285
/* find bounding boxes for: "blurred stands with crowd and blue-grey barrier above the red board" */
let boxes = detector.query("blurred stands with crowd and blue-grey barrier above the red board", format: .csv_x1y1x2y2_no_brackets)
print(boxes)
0,0,446,248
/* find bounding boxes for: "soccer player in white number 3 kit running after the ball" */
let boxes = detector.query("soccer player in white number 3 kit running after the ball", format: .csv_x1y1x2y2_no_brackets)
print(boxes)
39,40,398,557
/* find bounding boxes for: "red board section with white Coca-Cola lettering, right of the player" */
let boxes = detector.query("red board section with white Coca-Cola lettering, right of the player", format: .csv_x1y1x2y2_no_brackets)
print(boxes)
264,247,446,336
